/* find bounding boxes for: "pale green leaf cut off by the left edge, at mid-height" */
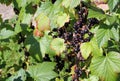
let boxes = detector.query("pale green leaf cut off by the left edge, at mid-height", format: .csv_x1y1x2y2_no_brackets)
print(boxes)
0,28,14,39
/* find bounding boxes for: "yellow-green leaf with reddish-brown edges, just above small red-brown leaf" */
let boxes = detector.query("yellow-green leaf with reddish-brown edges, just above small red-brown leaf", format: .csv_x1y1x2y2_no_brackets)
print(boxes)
36,13,50,31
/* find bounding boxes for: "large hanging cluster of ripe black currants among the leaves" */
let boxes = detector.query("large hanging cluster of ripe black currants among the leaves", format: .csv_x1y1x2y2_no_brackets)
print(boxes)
49,2,99,81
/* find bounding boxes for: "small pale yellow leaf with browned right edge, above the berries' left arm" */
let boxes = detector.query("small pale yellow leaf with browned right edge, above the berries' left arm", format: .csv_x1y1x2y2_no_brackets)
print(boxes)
57,13,69,27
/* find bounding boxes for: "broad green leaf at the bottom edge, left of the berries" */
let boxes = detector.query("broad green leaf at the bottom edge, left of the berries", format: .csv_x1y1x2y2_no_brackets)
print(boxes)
27,62,57,81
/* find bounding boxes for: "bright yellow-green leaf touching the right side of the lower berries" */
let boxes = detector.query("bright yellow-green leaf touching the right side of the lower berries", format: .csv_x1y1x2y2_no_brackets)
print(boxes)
80,38,102,59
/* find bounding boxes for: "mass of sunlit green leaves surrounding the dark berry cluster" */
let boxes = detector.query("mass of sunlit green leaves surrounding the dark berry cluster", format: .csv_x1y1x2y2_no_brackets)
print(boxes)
0,0,120,81
